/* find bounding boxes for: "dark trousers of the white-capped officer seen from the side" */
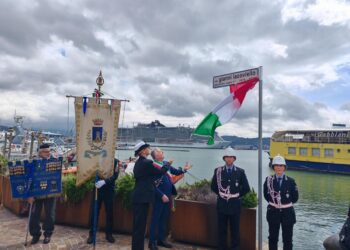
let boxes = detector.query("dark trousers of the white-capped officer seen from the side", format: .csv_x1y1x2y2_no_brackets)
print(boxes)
132,203,149,250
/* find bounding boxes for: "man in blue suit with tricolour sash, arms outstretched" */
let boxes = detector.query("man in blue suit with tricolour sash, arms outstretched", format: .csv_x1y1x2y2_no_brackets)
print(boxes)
148,148,191,250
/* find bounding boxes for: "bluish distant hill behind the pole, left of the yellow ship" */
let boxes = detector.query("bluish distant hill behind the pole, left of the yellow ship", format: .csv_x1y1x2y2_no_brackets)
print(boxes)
221,135,270,150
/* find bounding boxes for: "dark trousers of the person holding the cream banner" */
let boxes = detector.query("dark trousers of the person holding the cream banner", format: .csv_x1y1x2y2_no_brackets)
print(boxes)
89,189,114,236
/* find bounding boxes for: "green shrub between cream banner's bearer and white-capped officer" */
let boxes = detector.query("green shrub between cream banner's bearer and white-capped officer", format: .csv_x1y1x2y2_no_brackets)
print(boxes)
115,174,135,210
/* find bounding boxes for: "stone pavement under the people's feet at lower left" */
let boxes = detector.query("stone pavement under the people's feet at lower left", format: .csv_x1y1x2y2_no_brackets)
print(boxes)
0,208,210,250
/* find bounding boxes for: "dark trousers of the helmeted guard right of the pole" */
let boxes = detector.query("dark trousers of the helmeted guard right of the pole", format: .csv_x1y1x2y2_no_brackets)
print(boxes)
266,206,295,250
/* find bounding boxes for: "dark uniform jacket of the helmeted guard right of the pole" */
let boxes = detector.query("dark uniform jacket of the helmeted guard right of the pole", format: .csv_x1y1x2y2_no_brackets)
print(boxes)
264,175,299,224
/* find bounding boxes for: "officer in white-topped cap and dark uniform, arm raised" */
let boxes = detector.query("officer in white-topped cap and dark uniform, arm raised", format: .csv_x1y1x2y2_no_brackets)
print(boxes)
132,141,168,250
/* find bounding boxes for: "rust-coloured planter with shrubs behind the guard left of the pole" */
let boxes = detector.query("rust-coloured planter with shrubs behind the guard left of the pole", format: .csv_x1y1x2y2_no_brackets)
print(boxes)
170,180,257,250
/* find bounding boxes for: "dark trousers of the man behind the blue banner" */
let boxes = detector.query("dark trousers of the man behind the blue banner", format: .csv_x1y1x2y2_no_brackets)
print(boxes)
29,197,56,237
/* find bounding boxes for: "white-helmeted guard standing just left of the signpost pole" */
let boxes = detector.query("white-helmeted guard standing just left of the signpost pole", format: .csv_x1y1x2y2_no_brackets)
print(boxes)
211,147,250,250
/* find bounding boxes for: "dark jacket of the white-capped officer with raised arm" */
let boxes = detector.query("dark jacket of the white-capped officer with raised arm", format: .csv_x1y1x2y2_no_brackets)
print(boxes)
132,156,168,203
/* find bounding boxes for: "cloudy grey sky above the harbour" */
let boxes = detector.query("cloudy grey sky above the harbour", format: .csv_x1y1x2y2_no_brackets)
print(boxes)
0,0,350,137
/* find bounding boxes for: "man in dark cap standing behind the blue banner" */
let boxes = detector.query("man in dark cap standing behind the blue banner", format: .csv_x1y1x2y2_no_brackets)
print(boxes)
28,143,56,245
